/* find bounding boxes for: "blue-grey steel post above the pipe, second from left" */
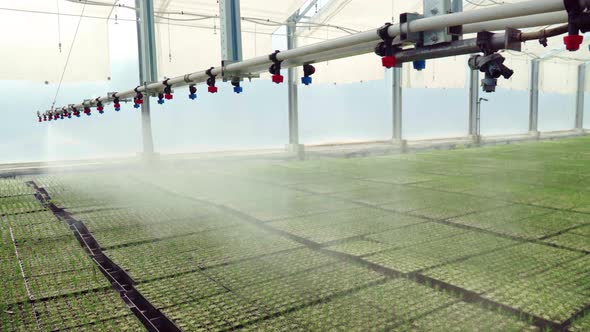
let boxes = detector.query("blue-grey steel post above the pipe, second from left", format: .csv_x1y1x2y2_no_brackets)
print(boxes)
219,0,242,64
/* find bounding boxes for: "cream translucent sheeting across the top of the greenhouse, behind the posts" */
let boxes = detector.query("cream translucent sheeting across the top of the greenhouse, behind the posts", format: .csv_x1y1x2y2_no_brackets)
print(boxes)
0,0,588,93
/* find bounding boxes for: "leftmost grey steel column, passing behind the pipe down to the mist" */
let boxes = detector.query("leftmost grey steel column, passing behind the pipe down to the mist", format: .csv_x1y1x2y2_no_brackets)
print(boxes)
135,0,158,157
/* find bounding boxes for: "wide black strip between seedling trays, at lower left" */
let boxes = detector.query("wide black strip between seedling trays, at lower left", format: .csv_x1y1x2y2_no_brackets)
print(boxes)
27,181,182,332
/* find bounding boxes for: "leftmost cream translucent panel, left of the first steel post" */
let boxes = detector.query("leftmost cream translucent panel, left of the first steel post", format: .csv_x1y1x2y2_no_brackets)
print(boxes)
0,0,111,83
